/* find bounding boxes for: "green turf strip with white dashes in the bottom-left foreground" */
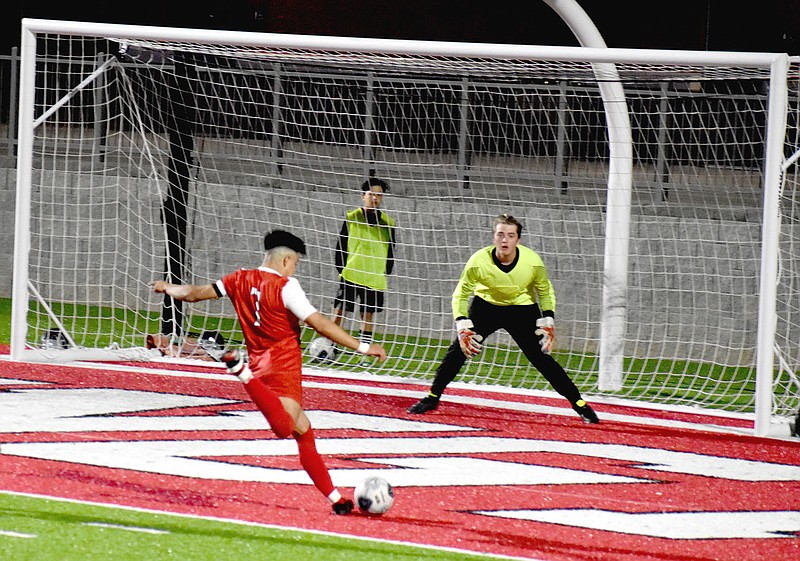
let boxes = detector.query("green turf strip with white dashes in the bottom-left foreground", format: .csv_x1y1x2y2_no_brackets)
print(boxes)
0,493,496,561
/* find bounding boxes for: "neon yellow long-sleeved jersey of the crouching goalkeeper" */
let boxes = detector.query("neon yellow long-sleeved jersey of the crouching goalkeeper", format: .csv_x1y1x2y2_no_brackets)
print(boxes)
453,245,556,318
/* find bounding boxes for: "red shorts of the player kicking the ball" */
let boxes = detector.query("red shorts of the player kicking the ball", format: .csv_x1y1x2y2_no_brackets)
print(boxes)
249,339,303,405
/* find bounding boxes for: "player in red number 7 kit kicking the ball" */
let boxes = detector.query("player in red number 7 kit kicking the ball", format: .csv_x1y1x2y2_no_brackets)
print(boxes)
151,230,386,514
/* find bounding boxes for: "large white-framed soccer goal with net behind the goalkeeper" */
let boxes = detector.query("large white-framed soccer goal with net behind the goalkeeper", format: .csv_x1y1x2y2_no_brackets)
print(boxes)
12,20,800,434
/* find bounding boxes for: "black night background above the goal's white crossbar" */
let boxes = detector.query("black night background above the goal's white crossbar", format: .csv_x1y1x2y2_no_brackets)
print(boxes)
0,0,800,55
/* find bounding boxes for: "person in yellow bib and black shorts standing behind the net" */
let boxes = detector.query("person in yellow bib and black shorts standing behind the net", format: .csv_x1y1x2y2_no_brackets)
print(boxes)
333,177,396,358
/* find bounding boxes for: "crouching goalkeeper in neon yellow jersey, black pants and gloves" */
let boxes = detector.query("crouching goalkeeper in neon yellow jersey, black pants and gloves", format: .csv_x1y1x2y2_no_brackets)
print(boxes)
408,214,600,423
